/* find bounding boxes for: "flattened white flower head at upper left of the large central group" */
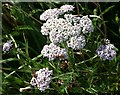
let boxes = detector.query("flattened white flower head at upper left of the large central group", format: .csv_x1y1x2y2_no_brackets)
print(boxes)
40,8,61,21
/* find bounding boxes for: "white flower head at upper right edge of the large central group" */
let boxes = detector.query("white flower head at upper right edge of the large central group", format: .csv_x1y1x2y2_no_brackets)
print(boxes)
80,16,94,33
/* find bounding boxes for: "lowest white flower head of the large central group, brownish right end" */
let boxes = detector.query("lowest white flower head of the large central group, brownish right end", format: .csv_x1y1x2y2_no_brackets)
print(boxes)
41,43,67,60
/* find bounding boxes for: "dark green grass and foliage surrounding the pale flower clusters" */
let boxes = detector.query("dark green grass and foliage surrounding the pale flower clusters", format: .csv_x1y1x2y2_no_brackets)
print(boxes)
0,2,120,95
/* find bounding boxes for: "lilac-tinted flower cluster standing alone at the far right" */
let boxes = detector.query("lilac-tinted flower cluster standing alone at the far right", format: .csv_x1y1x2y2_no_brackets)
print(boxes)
96,44,116,60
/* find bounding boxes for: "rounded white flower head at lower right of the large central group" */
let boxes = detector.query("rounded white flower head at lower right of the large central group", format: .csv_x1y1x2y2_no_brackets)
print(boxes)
67,35,86,50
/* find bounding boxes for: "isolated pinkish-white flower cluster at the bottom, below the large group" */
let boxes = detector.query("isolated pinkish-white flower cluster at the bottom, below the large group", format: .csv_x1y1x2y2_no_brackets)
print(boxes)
30,68,53,91
